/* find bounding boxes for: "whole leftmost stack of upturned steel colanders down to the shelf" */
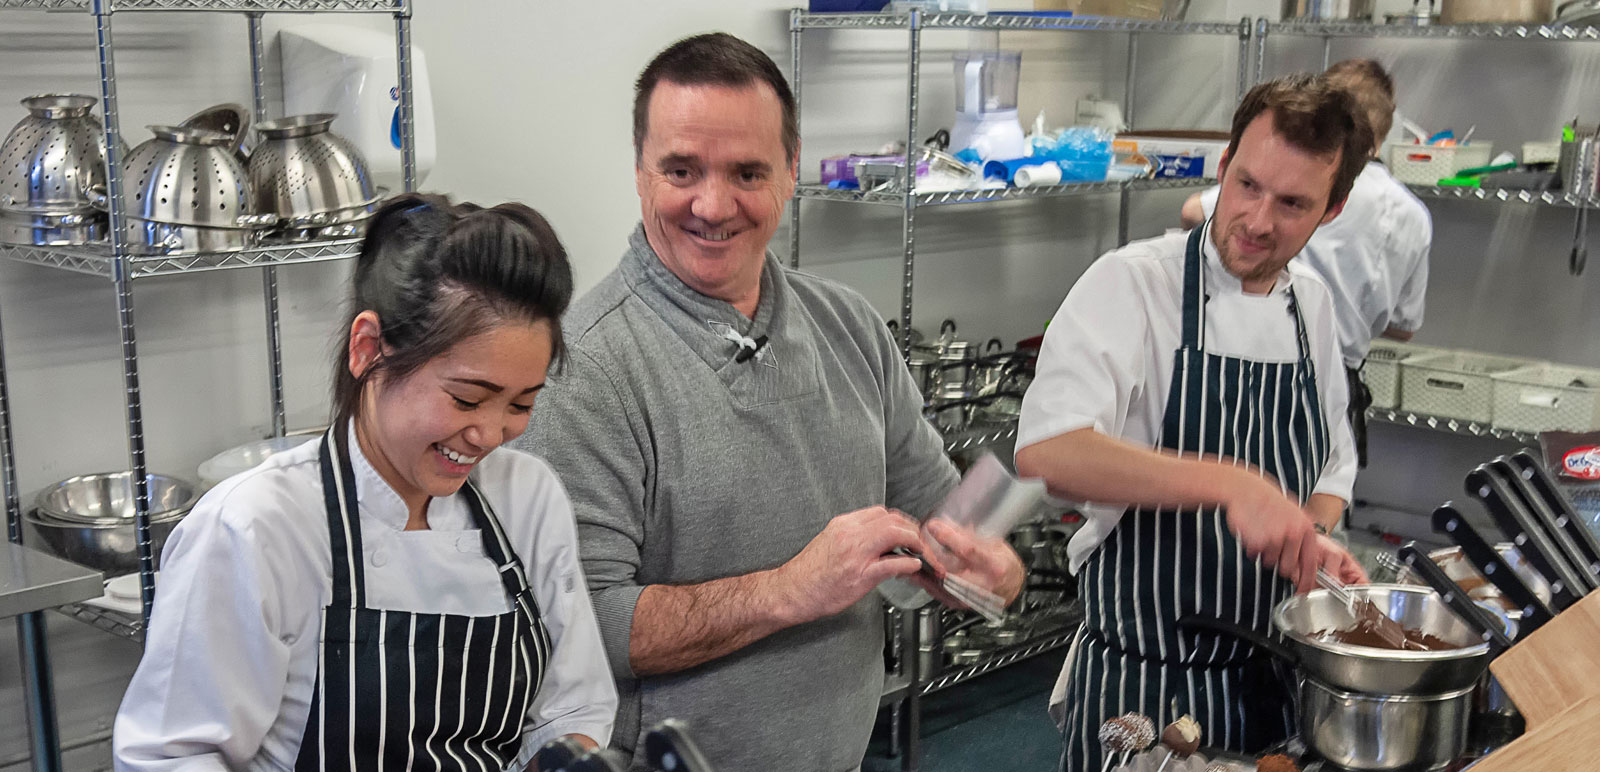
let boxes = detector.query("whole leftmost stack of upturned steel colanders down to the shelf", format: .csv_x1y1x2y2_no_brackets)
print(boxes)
0,94,126,247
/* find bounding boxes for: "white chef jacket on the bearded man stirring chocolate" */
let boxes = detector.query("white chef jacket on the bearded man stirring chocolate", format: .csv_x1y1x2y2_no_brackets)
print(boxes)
1016,225,1357,572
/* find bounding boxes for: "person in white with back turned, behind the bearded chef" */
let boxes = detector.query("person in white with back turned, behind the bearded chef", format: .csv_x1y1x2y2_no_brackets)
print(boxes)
1181,59,1434,466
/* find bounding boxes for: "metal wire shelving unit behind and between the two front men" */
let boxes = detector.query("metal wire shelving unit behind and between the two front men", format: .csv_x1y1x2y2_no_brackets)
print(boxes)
789,10,1254,770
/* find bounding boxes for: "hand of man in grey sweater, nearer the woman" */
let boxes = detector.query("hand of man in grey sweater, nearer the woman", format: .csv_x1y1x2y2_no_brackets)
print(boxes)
773,506,926,625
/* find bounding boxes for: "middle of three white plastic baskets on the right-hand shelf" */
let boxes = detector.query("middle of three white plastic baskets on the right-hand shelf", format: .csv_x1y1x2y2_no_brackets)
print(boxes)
1400,351,1534,424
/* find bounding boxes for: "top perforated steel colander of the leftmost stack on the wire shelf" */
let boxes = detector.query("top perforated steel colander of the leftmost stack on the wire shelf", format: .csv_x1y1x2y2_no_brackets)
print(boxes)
0,94,117,216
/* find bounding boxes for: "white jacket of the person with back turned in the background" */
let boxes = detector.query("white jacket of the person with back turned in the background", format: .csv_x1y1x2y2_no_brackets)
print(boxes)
1200,162,1434,368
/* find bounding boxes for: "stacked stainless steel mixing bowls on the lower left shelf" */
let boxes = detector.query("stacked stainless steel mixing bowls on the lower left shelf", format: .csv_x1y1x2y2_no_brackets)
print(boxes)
26,472,198,577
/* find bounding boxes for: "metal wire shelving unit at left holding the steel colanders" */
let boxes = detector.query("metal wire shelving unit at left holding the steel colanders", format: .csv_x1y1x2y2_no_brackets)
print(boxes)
0,0,416,772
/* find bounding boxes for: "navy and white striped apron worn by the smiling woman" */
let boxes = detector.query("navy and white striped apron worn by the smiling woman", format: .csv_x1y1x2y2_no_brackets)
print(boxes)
294,426,550,772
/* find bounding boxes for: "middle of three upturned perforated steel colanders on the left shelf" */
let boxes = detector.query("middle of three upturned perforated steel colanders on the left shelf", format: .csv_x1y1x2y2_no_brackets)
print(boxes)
123,125,275,255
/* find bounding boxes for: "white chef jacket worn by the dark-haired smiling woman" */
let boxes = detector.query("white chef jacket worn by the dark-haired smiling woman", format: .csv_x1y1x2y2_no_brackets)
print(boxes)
112,432,616,770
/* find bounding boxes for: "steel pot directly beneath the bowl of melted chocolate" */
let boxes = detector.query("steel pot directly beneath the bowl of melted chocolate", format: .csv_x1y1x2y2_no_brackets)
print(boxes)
1299,678,1472,772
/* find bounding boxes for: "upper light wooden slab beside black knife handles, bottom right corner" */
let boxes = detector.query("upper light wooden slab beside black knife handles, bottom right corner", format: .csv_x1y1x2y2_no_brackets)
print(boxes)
1490,593,1600,730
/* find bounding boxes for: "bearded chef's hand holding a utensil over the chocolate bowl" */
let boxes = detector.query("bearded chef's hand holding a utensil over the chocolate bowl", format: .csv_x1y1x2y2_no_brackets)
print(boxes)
1224,469,1338,591
